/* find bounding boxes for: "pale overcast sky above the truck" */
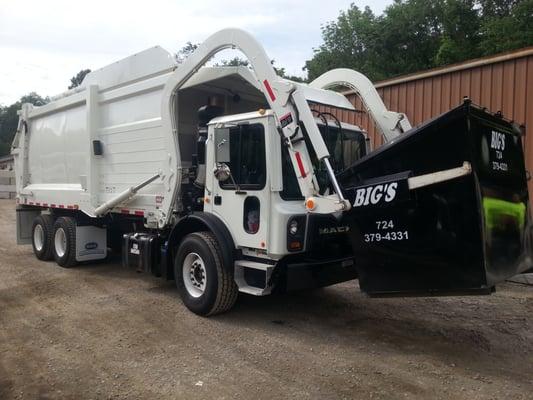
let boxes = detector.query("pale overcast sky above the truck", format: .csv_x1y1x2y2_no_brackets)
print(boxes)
0,0,392,105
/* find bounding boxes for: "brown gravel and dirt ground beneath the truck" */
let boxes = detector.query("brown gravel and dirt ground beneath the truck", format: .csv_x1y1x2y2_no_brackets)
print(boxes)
0,200,533,399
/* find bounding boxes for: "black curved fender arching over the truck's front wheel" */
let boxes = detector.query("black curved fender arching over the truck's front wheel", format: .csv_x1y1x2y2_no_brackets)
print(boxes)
166,212,236,279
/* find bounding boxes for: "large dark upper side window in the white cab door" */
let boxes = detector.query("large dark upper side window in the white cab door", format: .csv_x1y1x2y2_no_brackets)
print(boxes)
220,124,266,190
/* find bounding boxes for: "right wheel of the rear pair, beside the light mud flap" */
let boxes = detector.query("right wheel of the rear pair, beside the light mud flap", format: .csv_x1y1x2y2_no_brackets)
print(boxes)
52,217,77,268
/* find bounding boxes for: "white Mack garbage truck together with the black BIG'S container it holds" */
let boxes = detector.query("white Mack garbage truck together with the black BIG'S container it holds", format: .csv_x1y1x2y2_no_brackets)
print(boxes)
12,29,531,315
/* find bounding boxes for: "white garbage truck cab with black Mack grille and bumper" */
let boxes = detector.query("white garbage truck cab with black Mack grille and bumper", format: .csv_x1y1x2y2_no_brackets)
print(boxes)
203,110,367,295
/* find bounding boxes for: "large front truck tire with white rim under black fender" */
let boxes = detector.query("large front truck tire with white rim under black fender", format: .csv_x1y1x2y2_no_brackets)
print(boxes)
174,232,238,316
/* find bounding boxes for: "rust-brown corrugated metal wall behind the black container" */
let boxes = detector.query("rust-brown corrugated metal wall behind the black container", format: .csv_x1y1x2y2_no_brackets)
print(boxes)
314,48,533,198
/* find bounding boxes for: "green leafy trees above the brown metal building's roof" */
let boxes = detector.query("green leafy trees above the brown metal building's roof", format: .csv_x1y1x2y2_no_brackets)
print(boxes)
304,0,533,80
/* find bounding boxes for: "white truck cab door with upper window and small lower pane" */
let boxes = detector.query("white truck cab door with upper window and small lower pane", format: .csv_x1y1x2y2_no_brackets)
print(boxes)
206,120,270,250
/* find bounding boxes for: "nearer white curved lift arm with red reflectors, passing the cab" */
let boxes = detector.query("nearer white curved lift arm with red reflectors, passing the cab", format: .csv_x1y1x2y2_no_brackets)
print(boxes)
163,29,350,213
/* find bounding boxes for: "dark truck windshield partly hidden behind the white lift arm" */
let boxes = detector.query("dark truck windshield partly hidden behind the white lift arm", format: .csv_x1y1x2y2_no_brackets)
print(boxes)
280,124,366,200
